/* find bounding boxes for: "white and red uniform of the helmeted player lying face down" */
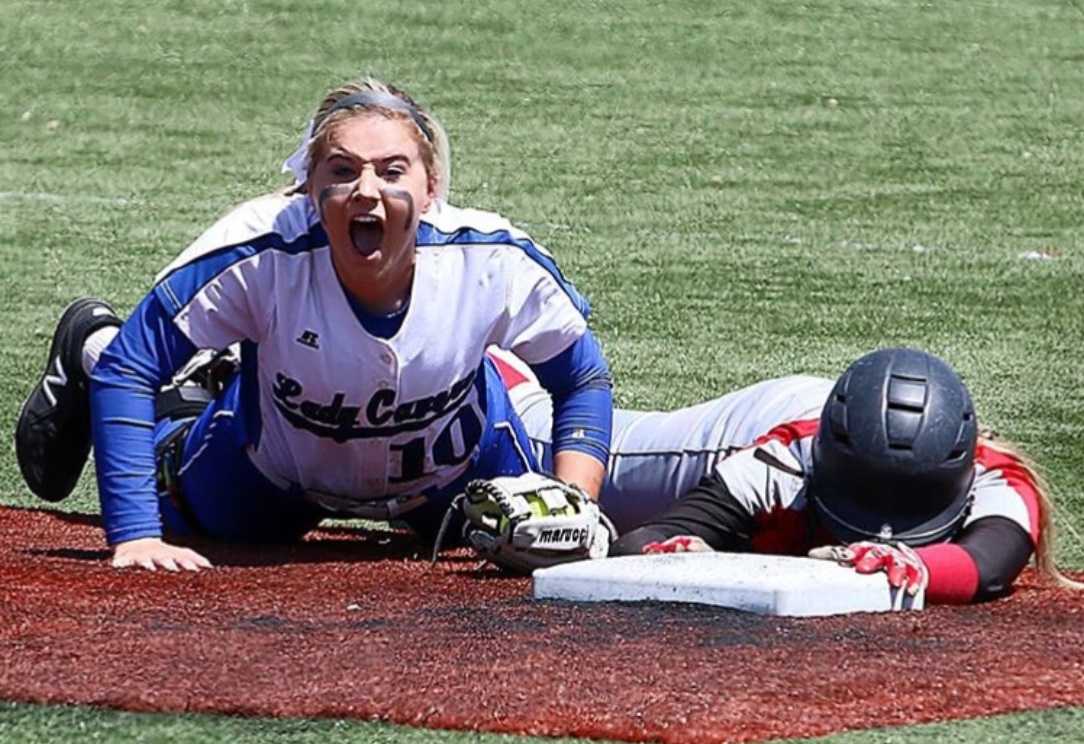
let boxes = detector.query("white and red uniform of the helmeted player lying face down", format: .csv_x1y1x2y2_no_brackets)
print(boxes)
493,351,1040,544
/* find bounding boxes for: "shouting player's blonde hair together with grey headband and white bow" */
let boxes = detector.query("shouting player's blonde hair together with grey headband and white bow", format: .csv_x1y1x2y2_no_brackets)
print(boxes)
282,77,452,202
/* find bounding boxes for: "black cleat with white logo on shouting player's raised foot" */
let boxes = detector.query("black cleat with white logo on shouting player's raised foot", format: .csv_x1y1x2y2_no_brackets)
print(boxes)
15,297,121,501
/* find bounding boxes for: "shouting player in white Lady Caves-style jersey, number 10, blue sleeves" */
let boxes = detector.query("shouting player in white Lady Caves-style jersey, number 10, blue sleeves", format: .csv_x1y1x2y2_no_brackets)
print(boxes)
16,80,611,569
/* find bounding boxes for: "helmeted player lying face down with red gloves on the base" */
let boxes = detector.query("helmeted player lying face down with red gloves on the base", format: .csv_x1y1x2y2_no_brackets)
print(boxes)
472,348,1081,603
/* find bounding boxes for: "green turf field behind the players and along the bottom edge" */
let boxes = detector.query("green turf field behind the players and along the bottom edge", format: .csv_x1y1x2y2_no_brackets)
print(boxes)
0,0,1084,743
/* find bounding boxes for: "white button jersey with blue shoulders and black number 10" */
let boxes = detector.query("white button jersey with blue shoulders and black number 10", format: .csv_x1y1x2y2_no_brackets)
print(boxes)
155,194,586,507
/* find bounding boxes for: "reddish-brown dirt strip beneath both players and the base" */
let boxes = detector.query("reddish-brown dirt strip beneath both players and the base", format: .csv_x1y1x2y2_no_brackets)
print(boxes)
0,509,1084,742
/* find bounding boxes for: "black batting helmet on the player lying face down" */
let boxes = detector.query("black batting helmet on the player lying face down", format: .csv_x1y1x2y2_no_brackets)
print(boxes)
806,348,978,546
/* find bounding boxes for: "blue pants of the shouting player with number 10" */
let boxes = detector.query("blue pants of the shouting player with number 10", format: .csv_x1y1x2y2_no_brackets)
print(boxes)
155,359,539,542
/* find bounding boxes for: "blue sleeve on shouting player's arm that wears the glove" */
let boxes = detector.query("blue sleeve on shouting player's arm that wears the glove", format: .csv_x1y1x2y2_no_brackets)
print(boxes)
531,331,614,465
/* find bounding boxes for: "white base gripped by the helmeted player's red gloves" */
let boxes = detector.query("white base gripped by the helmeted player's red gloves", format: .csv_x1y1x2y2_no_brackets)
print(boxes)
533,553,925,617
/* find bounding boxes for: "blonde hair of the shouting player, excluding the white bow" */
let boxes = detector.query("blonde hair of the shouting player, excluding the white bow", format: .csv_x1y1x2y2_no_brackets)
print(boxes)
309,77,452,201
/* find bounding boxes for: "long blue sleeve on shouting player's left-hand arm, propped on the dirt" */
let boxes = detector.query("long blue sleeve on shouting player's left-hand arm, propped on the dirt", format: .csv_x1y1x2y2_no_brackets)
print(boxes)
90,293,196,544
